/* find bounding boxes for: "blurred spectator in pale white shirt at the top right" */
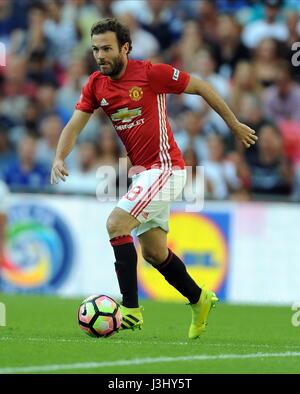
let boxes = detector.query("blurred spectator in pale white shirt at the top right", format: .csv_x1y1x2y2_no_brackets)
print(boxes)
242,0,288,49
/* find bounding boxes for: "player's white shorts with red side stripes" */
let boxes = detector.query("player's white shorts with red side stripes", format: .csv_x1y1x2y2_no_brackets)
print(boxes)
117,169,186,236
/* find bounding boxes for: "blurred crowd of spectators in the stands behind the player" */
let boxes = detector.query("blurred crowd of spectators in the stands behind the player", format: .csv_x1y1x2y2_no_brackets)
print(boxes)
0,0,300,201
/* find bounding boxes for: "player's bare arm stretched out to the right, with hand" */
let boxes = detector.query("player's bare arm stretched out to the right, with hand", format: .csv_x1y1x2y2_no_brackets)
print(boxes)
184,75,257,148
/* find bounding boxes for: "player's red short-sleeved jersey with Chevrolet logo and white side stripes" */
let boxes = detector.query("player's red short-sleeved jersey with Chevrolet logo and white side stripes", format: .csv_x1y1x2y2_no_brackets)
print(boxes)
76,60,189,170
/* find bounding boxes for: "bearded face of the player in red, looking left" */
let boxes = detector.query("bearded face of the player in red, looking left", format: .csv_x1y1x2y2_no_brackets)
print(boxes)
92,31,128,78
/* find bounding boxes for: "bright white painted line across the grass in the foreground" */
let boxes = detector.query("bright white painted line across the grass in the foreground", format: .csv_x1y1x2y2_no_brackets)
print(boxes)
0,352,300,374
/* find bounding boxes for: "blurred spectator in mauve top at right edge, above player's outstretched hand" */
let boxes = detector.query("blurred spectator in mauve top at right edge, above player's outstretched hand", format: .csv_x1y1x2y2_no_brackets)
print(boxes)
263,60,300,122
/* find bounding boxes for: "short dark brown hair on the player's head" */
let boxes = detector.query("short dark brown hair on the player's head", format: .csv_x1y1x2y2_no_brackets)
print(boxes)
91,18,132,53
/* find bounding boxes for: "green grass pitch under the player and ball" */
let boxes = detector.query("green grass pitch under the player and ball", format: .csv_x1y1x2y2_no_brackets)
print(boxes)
0,294,300,374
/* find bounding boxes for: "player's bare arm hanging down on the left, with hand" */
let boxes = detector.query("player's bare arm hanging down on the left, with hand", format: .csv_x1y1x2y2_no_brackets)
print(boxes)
51,110,92,184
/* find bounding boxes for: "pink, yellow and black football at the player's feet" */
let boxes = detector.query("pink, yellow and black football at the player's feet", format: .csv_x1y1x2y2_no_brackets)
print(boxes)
78,295,122,338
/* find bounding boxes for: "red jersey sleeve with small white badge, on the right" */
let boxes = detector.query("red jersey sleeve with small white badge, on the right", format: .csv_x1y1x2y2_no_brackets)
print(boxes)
147,63,190,94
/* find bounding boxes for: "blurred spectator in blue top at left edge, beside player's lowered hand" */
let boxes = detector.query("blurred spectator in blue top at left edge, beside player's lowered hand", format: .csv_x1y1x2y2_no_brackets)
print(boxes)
3,135,50,191
